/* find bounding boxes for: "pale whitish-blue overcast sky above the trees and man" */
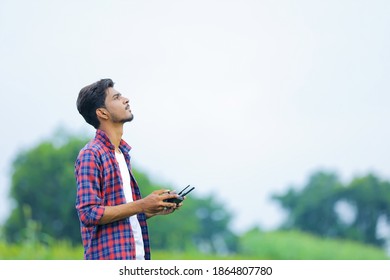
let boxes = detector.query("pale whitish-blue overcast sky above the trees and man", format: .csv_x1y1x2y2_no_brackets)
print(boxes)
0,0,390,232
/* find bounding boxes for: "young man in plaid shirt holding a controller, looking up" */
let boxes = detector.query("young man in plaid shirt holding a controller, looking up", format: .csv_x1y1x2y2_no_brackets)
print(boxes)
75,79,181,260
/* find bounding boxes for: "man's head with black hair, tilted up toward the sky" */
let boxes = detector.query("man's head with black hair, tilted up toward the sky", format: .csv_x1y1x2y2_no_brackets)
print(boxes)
76,79,133,129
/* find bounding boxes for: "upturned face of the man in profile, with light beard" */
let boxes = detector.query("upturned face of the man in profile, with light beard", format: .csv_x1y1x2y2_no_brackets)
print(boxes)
105,87,134,123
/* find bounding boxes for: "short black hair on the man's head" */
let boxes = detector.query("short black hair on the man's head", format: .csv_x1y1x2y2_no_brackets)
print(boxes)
76,79,114,129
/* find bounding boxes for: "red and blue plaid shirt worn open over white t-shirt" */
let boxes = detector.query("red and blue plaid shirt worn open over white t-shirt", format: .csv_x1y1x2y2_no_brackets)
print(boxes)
75,129,150,260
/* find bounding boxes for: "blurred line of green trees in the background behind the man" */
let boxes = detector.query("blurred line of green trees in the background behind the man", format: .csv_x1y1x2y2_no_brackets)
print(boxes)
3,130,390,254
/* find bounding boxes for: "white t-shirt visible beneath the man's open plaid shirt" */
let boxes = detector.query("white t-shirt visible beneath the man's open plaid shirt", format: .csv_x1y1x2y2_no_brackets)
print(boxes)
115,151,145,260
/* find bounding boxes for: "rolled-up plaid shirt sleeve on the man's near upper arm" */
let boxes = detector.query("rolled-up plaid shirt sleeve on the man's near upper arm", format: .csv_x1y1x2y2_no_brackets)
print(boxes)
75,149,104,227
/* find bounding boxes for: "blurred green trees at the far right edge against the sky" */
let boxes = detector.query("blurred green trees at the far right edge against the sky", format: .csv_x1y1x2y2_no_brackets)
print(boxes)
272,172,390,245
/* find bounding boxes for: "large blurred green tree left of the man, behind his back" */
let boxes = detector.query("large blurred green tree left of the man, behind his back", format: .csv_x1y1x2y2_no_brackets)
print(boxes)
4,132,87,243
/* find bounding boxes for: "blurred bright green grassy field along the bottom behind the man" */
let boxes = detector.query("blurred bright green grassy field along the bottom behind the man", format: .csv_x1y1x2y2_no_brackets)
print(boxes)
0,231,389,260
